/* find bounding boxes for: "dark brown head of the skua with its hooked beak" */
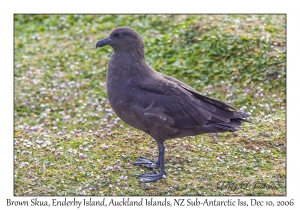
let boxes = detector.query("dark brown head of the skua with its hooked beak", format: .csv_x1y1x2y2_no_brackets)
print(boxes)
96,27,144,53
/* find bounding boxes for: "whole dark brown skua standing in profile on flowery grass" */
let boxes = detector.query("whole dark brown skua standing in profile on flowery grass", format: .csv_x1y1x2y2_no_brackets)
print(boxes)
96,27,251,182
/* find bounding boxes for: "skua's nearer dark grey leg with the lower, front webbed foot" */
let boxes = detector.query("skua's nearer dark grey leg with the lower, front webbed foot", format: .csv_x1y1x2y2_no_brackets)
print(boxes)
138,143,166,182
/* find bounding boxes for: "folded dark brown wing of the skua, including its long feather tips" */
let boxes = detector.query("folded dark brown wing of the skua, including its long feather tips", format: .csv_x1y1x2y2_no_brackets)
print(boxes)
130,75,246,128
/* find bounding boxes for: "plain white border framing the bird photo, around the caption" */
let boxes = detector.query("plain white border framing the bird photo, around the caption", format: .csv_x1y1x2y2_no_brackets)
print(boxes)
0,0,300,209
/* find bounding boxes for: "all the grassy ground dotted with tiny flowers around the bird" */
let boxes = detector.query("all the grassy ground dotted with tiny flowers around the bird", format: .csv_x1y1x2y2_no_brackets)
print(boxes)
14,15,286,195
